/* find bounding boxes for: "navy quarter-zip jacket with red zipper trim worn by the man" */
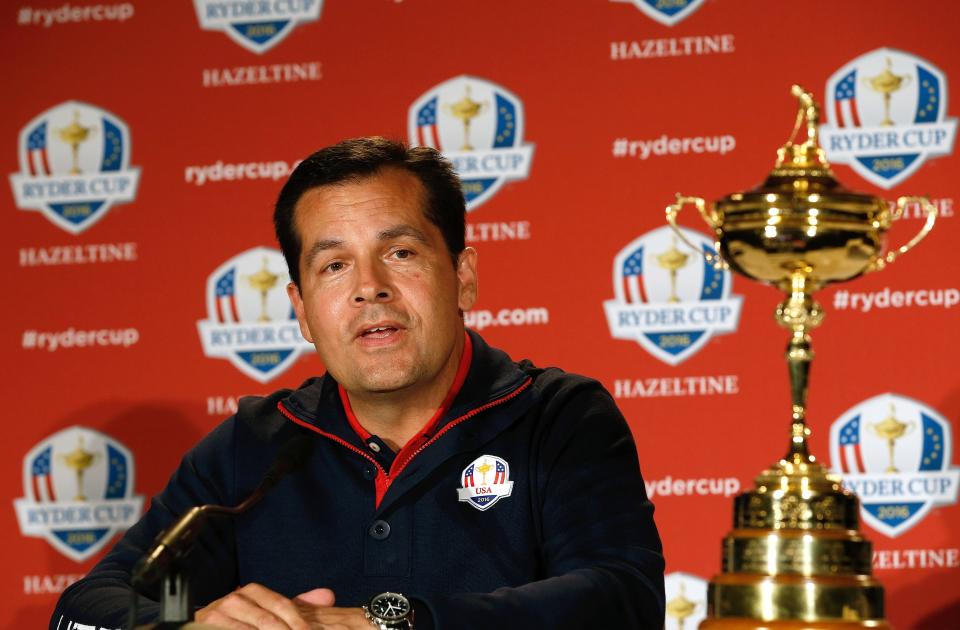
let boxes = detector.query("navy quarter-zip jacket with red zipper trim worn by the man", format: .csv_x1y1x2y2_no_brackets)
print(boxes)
50,333,664,630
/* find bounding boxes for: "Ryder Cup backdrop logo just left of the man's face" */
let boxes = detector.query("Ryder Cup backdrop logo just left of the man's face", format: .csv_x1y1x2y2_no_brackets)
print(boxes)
197,247,313,383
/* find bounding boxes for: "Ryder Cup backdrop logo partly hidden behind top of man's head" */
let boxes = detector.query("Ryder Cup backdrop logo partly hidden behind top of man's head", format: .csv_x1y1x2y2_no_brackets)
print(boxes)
408,75,533,210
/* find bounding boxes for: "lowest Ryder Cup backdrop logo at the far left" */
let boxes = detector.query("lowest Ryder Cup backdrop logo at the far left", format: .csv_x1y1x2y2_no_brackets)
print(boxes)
14,427,143,562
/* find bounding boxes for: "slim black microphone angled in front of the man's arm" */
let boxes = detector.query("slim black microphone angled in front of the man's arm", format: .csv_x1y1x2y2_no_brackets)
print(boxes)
133,433,315,586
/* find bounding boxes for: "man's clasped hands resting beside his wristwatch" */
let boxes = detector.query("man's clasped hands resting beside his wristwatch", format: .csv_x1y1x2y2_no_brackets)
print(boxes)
196,584,372,630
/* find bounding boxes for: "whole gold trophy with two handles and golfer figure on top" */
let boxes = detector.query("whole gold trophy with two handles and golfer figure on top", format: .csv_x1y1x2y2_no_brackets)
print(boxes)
667,85,937,630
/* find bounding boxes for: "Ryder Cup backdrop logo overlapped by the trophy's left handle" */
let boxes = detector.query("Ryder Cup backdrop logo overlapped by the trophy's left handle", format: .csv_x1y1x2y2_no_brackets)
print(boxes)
603,226,743,365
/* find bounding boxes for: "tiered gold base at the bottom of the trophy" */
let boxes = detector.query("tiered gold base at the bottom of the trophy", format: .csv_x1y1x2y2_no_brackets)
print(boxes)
700,457,891,630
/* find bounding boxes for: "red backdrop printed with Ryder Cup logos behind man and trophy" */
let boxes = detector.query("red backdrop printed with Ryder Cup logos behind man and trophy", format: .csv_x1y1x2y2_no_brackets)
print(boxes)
0,0,960,628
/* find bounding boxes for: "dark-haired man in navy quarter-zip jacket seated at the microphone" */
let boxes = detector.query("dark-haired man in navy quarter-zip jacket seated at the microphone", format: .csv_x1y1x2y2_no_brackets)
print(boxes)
51,138,664,630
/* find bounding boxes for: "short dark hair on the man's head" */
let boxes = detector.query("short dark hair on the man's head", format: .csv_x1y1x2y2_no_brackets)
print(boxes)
273,137,467,287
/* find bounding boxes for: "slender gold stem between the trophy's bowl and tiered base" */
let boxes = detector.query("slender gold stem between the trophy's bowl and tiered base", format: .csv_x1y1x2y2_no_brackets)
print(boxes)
777,268,823,464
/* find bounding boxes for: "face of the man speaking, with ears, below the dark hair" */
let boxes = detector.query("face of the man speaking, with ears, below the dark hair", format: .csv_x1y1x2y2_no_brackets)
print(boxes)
287,169,477,396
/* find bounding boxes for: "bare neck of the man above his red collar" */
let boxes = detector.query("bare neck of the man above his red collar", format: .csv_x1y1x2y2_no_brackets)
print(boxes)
347,337,464,452
